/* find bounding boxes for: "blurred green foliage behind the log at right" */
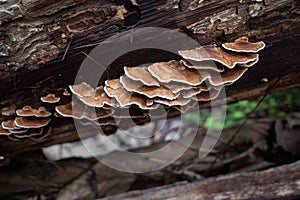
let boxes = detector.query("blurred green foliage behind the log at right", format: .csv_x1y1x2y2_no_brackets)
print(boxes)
184,88,300,129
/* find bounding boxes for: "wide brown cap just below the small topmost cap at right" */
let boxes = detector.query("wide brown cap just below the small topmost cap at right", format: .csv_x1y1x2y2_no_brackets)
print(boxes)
179,45,258,69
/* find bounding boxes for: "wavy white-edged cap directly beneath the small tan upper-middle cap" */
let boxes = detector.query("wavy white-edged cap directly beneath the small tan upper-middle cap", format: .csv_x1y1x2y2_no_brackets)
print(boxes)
120,76,179,100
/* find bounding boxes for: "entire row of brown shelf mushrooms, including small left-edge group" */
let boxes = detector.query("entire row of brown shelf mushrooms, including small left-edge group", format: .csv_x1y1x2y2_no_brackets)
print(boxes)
0,37,265,139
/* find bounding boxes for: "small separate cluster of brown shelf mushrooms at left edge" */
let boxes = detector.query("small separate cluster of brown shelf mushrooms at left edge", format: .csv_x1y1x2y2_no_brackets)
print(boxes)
0,106,51,140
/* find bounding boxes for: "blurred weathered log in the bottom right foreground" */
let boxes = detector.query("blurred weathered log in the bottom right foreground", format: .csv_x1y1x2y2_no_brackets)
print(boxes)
103,161,300,200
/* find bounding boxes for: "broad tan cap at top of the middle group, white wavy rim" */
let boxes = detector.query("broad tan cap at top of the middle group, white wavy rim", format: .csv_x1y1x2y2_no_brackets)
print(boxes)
148,60,209,86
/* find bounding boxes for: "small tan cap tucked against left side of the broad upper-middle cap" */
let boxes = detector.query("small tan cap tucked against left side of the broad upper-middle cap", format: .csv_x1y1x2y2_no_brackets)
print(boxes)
124,67,159,86
